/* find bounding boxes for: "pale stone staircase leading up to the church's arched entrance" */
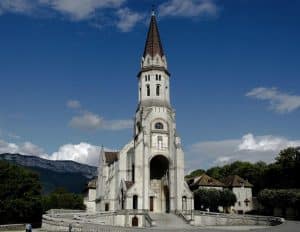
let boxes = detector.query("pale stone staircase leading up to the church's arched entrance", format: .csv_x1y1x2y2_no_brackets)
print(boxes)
149,213,193,230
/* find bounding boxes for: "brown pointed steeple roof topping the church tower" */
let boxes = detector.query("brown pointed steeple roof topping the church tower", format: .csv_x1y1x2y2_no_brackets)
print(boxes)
143,11,164,58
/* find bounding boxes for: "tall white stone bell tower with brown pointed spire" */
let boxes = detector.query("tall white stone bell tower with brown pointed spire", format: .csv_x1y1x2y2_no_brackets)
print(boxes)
134,11,193,212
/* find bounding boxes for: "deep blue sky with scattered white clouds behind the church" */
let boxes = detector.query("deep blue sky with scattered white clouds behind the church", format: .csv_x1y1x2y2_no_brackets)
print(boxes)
0,0,300,171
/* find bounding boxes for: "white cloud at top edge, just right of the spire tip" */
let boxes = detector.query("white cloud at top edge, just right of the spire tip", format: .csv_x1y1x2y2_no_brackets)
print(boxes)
158,0,218,17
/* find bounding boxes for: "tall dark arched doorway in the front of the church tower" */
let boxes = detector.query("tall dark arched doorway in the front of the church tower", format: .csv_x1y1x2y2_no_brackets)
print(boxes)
150,155,170,213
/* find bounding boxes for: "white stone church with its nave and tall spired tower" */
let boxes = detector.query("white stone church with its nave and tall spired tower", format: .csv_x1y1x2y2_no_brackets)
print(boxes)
96,13,194,213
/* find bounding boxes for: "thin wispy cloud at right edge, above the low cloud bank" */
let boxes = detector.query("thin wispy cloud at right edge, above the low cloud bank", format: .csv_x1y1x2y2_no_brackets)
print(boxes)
246,87,300,113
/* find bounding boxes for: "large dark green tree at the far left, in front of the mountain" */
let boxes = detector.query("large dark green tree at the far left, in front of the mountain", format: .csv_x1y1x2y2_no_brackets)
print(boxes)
0,161,43,224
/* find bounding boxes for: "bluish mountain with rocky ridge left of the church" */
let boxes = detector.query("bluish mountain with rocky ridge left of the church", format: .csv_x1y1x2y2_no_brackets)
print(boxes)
0,153,97,193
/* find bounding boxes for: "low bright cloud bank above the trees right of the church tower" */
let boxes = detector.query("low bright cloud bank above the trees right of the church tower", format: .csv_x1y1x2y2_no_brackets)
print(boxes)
186,133,300,171
